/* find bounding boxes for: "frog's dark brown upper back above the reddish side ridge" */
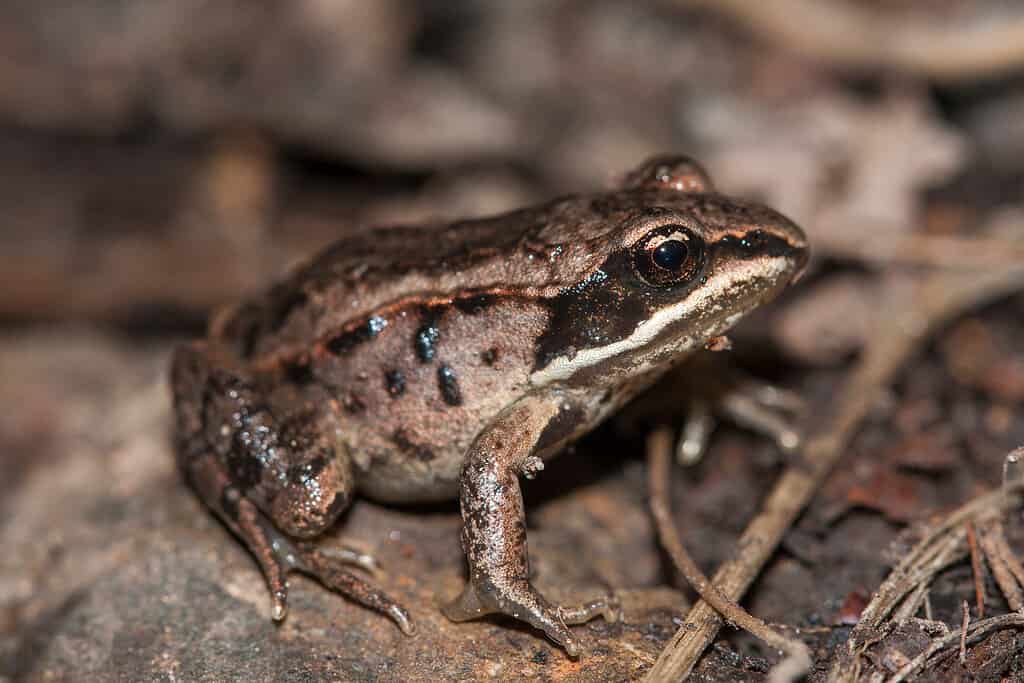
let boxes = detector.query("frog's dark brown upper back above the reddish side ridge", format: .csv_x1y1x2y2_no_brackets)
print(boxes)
217,201,556,361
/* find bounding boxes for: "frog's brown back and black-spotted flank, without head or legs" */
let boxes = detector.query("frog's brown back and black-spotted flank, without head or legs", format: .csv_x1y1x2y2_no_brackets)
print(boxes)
205,199,606,502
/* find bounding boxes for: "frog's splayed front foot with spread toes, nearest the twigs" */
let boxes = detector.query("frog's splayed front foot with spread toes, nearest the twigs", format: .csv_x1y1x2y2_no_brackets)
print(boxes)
441,580,621,657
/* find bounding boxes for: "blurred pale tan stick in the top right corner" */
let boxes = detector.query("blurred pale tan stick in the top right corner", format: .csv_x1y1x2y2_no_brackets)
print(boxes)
682,0,1024,81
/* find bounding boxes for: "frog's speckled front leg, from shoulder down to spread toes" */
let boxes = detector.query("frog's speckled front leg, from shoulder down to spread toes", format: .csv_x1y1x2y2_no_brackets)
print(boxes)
444,397,617,656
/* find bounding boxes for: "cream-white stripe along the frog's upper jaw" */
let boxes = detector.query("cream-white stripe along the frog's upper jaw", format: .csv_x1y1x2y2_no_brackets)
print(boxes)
529,256,794,387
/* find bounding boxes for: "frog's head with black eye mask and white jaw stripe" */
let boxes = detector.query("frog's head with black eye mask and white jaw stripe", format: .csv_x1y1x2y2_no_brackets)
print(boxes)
531,157,808,385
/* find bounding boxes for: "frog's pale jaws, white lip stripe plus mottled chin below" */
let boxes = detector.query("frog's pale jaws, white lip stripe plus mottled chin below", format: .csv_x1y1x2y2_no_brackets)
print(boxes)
530,243,807,386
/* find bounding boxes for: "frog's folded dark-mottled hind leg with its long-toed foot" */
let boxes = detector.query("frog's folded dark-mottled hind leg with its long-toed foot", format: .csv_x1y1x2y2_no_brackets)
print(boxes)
172,344,413,634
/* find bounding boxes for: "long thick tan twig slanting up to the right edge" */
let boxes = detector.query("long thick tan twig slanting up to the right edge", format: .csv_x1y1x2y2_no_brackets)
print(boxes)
647,264,1024,681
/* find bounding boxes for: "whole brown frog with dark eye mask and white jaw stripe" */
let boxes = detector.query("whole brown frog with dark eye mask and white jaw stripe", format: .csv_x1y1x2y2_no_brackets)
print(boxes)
170,155,808,657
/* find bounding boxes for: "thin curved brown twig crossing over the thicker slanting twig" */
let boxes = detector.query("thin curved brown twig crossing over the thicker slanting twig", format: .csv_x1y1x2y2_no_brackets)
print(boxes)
647,428,811,683
